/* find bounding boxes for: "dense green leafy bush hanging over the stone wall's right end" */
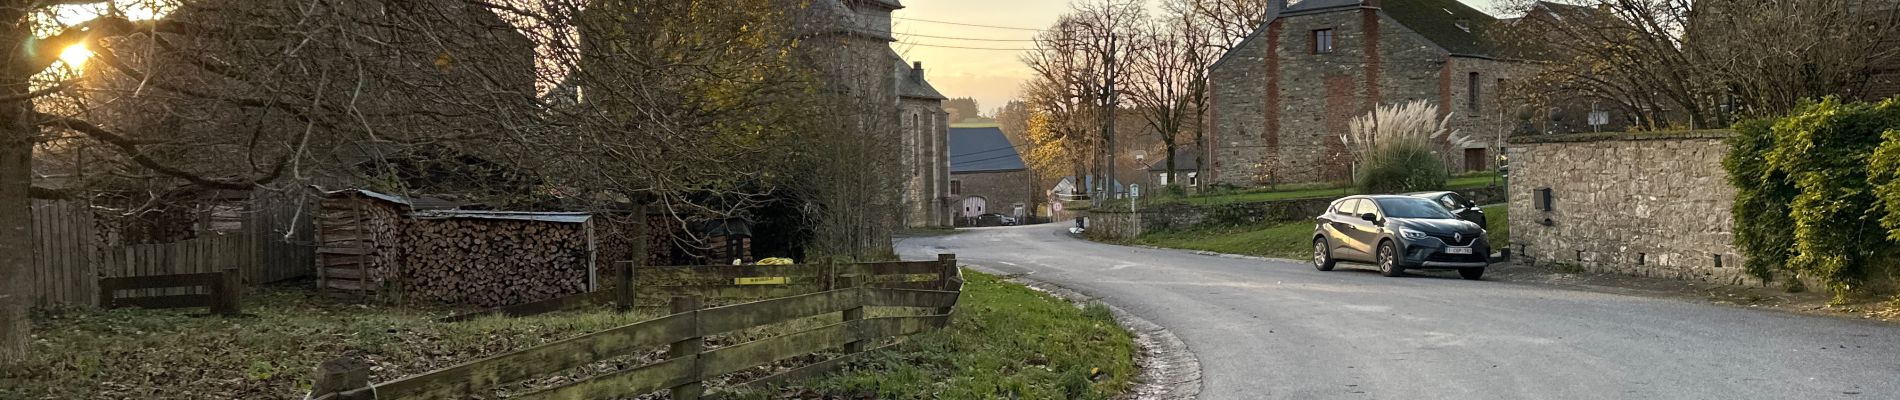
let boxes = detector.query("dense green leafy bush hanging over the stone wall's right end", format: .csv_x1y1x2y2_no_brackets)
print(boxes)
1723,99,1900,301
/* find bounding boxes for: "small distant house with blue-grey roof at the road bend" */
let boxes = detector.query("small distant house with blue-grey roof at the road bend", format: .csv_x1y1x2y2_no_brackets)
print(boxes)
950,127,1037,226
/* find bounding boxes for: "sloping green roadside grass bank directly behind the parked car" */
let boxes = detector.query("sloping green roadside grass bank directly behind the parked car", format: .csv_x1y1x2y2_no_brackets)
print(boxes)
1134,205,1511,260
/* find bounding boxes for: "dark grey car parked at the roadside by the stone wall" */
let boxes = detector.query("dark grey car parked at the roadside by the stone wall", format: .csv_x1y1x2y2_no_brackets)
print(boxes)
1313,195,1492,281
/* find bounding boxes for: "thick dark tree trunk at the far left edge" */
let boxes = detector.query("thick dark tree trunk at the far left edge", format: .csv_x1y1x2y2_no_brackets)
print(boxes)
0,2,36,364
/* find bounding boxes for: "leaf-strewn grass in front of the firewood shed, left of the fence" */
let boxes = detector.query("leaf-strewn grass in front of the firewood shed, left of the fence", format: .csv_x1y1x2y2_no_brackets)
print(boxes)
0,288,657,398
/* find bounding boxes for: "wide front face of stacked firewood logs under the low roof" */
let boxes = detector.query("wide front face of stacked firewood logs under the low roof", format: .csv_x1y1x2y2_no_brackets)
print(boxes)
401,218,591,307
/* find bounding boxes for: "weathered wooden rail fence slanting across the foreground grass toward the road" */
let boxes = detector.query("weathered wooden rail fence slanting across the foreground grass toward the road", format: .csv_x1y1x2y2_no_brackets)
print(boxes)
310,256,963,400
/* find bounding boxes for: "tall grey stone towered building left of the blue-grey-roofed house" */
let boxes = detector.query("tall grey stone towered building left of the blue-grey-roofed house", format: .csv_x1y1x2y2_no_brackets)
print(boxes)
790,0,954,227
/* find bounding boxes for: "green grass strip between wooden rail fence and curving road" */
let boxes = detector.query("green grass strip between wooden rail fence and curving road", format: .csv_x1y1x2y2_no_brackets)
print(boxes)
737,271,1136,398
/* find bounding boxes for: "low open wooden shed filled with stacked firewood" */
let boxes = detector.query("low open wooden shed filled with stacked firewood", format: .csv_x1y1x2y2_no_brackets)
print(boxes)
317,190,597,307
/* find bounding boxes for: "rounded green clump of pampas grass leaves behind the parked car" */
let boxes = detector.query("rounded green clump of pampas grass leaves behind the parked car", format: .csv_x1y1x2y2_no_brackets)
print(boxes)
1353,142,1452,193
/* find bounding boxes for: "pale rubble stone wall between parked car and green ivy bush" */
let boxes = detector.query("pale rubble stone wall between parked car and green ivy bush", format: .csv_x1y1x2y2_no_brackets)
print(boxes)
1509,131,1759,284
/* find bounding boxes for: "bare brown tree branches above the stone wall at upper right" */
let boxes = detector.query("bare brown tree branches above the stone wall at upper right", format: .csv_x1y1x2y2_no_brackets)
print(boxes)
1497,0,1900,129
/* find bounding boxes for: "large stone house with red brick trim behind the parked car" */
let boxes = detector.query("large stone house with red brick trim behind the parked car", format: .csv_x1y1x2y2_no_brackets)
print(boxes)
1201,0,1518,186
